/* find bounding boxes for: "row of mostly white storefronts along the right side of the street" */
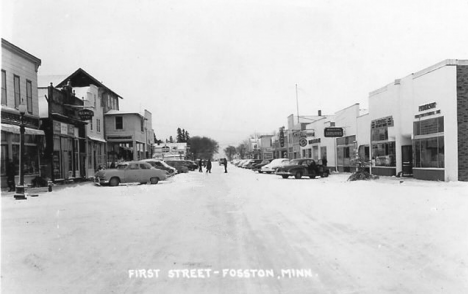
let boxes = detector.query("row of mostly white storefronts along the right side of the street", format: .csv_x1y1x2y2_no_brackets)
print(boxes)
259,59,468,181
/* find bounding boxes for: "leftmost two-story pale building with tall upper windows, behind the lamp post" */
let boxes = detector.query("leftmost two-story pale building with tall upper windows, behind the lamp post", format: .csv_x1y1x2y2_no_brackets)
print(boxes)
0,39,44,187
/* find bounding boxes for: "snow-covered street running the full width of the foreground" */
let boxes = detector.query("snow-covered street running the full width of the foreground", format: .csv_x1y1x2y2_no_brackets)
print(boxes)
1,165,468,294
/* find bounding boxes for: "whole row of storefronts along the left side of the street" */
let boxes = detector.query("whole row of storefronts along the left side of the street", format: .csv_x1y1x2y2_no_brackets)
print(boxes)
1,39,154,188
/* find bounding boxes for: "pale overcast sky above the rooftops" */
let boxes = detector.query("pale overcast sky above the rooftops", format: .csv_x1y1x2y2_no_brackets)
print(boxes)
1,0,468,147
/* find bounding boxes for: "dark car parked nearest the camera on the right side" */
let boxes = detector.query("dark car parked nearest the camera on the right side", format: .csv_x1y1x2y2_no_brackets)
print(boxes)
276,158,330,179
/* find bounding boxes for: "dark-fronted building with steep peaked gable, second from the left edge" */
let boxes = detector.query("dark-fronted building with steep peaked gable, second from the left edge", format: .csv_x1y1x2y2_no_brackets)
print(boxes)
39,68,122,181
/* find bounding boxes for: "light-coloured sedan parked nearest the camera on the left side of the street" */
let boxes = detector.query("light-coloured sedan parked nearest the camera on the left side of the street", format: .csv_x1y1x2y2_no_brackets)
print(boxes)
94,161,167,186
